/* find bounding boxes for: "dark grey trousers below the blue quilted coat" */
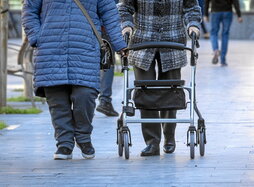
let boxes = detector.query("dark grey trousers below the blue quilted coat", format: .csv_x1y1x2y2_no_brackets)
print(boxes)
44,85,98,150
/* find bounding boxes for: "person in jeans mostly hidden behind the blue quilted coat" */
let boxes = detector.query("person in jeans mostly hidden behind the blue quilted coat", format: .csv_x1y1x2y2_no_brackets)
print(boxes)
96,0,119,116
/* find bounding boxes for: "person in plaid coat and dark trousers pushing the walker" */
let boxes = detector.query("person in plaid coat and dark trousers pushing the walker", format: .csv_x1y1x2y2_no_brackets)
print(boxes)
118,0,201,156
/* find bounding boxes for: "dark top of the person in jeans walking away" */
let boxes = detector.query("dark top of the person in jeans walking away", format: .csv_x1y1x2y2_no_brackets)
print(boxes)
205,0,241,17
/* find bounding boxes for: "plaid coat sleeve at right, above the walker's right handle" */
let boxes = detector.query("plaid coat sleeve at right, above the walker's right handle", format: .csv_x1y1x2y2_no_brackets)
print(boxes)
183,0,202,29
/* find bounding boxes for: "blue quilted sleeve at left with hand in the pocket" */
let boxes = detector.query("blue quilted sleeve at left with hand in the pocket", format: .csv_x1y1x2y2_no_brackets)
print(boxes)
21,0,42,47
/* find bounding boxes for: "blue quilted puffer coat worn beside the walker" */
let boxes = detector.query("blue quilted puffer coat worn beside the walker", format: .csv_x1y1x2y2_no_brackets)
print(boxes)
22,0,126,95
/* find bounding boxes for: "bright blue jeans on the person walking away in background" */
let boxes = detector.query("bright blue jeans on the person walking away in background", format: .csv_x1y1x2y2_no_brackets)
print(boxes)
211,12,233,64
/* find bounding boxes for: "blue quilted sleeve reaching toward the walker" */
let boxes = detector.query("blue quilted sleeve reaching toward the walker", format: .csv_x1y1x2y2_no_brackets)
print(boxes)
98,0,127,51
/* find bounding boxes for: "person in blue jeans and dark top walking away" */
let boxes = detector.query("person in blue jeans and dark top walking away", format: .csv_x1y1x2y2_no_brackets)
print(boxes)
205,0,243,66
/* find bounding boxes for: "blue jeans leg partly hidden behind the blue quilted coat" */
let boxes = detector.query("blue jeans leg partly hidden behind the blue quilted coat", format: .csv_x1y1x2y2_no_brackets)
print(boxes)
99,67,114,102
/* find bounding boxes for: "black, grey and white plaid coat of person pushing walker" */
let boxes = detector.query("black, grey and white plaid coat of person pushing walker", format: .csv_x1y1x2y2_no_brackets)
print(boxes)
118,0,201,72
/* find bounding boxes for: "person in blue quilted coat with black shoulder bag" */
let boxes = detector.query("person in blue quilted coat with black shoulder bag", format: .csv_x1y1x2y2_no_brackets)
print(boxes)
22,0,126,159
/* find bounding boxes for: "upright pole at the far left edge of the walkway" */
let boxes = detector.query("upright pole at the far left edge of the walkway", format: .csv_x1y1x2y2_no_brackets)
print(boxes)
0,0,9,107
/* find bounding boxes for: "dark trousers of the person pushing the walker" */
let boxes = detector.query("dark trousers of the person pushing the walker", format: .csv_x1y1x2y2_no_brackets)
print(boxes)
134,52,181,145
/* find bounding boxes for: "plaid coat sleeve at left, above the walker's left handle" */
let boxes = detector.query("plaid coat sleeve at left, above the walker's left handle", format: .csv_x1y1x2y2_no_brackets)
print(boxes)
117,0,137,29
